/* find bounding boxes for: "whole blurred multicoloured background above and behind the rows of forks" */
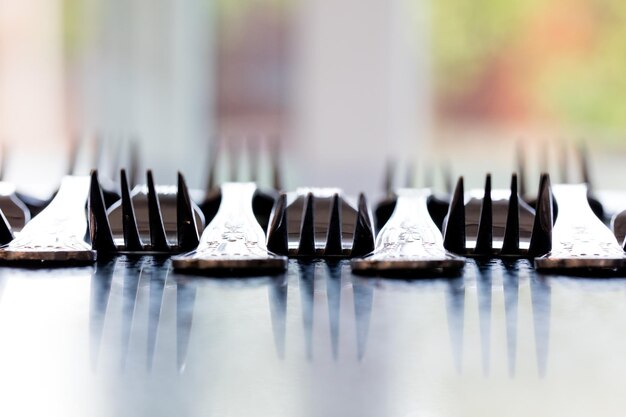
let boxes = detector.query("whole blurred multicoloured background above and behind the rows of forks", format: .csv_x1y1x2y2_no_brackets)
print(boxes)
0,0,626,194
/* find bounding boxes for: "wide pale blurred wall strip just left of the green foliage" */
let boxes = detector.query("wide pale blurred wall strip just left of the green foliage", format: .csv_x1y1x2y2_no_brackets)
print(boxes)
290,0,430,196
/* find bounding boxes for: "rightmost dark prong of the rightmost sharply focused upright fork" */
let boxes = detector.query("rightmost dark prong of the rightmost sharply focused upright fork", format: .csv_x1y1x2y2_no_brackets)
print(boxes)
528,174,554,257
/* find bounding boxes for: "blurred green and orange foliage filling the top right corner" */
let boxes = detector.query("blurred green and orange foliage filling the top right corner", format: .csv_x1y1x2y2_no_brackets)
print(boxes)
431,0,626,131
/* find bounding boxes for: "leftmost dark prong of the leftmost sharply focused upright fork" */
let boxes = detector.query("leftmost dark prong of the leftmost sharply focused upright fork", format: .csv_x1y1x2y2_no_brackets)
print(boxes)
89,169,117,252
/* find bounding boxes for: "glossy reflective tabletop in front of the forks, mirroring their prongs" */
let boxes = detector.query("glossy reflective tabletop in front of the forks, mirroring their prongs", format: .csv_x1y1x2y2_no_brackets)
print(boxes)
0,257,626,417
